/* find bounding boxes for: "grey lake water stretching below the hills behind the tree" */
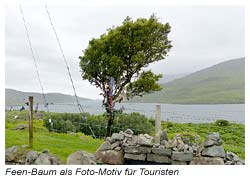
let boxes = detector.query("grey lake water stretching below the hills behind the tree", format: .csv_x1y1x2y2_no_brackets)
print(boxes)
8,101,245,124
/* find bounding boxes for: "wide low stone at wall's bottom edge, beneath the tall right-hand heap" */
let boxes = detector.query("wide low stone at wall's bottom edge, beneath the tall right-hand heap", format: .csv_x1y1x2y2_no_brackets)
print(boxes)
190,156,224,165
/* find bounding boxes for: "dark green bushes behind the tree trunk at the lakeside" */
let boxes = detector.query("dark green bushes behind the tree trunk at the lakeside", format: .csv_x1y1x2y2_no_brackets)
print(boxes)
43,113,154,137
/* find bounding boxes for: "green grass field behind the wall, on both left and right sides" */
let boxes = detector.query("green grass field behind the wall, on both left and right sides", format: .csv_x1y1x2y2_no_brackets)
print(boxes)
5,111,245,163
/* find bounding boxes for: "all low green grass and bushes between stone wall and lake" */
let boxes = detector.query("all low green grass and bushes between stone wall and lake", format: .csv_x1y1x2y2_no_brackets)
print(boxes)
5,111,245,164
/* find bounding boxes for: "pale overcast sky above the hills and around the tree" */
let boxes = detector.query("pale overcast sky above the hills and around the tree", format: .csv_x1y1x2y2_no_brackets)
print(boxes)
6,6,244,99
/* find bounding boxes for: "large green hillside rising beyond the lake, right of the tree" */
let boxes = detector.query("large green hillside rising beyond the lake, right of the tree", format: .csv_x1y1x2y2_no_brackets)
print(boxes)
132,58,245,104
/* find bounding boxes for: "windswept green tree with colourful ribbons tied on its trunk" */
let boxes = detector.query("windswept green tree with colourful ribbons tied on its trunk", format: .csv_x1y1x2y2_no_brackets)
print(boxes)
79,15,172,136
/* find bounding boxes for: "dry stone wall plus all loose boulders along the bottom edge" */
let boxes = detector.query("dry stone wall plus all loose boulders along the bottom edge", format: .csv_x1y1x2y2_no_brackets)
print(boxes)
5,129,245,165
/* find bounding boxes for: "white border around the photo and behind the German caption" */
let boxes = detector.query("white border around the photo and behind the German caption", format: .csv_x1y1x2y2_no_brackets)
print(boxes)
0,0,250,180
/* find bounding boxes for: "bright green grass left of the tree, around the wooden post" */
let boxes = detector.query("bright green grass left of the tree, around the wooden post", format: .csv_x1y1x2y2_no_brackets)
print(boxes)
5,111,103,164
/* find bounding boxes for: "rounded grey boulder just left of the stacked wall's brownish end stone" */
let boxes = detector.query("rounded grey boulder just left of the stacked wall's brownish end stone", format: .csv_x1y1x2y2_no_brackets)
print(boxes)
67,151,96,165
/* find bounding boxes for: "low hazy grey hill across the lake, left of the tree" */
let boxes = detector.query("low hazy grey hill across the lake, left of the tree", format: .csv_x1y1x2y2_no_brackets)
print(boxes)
5,89,90,106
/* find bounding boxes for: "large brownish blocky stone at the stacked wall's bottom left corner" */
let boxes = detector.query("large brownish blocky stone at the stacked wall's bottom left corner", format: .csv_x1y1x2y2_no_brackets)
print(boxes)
95,150,124,165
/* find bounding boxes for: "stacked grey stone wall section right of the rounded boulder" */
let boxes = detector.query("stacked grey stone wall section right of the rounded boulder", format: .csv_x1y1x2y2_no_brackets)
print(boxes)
95,129,244,165
